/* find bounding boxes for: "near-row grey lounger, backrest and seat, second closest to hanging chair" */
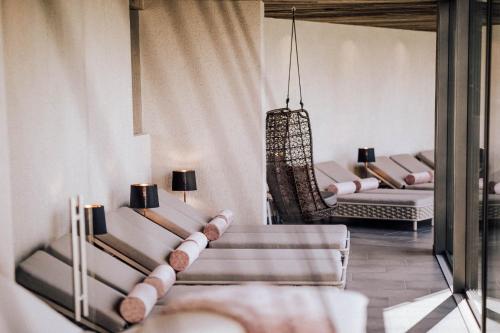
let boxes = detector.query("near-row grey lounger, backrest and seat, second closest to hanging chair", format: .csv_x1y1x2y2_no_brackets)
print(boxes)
88,207,347,288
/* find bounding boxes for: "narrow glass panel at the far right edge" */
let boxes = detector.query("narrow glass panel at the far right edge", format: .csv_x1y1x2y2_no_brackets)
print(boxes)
486,0,500,326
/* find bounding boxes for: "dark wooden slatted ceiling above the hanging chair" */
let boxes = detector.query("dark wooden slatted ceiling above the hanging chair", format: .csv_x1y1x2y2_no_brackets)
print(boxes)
264,0,437,31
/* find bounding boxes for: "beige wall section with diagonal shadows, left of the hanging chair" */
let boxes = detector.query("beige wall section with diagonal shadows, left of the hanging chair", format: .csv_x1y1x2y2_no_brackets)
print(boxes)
140,0,265,223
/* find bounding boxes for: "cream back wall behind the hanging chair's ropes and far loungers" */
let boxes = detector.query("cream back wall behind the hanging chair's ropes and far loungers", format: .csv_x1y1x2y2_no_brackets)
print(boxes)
264,18,436,170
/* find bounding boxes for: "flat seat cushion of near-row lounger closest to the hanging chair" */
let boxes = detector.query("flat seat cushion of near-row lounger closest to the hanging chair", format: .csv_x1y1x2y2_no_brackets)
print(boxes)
210,233,347,250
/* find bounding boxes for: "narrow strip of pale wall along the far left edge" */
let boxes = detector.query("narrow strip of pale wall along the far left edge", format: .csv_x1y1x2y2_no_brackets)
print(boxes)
0,0,14,278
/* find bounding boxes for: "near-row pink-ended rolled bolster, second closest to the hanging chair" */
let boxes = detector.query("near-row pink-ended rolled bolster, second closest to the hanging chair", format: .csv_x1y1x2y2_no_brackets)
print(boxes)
168,232,208,272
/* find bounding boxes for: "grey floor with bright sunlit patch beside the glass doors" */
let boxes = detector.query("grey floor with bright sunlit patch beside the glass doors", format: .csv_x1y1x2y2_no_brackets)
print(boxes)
346,223,476,333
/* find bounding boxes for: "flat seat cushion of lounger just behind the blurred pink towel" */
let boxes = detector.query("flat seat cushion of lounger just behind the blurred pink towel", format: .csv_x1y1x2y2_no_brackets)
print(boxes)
177,252,343,286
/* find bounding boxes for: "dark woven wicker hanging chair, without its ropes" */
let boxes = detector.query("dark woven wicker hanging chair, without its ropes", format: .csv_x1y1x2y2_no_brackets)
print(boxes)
266,108,336,223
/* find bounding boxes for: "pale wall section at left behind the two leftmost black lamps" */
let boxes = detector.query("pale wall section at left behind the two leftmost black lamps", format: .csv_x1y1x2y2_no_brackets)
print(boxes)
3,0,150,260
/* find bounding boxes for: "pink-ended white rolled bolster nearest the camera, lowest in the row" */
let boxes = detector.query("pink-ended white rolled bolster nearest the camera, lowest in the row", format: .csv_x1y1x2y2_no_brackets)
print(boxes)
120,283,156,323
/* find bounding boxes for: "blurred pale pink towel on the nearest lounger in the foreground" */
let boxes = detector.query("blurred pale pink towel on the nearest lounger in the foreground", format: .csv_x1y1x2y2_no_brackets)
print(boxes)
163,285,335,333
